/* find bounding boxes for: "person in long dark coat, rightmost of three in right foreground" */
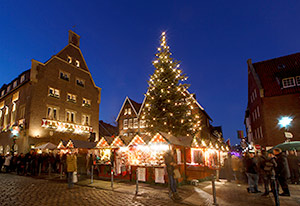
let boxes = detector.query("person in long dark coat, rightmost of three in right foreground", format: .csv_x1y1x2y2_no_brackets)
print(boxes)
273,148,290,196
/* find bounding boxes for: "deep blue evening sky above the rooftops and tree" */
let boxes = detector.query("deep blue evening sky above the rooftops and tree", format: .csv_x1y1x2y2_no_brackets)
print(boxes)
0,0,300,145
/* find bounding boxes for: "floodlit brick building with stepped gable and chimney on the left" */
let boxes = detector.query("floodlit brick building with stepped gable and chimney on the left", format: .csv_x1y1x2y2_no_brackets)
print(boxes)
0,31,101,152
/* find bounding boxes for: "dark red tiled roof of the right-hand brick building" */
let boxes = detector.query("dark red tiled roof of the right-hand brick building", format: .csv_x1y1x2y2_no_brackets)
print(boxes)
252,53,300,97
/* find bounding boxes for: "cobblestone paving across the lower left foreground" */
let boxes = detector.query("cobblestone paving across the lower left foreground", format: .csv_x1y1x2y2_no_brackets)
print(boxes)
0,174,189,206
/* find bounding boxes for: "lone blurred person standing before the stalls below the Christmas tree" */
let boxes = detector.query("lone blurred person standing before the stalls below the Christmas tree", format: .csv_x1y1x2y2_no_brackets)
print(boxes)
164,150,181,201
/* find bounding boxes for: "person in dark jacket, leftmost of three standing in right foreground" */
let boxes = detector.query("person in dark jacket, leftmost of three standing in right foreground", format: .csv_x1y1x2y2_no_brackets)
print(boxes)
245,151,260,193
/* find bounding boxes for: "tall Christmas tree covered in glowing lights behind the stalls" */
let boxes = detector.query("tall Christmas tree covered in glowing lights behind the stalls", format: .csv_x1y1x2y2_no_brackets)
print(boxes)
142,32,200,137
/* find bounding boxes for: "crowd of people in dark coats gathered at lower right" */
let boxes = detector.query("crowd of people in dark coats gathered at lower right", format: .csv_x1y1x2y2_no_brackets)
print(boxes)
225,148,300,205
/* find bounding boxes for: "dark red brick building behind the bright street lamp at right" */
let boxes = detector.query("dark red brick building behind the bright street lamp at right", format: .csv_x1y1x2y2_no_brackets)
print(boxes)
245,53,300,146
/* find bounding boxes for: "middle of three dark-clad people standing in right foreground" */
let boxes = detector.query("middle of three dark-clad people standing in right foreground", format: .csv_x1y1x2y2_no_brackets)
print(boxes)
261,153,280,206
